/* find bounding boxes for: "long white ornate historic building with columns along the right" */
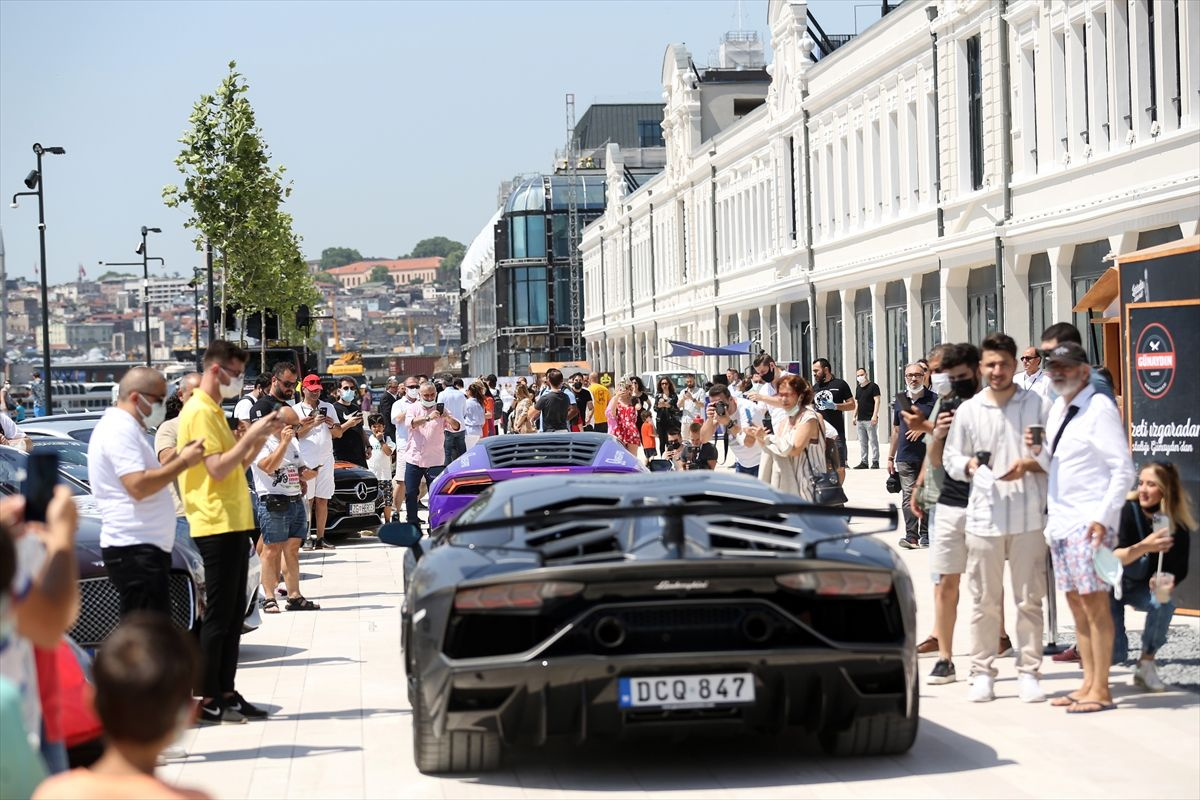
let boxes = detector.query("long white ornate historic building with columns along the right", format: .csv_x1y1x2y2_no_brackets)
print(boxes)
581,0,1200,424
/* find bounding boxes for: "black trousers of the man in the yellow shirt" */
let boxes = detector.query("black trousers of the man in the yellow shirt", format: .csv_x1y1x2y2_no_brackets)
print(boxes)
192,530,252,698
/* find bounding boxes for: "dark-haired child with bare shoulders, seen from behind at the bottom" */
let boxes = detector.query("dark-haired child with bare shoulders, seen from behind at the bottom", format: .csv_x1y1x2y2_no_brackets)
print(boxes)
34,612,208,800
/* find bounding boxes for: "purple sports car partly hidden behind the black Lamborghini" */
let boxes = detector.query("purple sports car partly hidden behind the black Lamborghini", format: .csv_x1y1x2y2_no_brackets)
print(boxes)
428,433,647,529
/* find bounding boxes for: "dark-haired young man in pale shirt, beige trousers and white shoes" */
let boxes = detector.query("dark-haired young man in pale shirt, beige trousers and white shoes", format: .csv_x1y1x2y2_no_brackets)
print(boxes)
942,333,1050,703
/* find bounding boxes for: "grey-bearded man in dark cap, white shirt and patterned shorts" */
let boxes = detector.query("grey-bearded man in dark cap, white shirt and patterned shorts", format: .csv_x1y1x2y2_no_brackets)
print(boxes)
1043,342,1134,714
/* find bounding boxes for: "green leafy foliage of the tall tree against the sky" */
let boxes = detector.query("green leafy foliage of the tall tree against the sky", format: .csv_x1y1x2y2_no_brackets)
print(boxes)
162,61,319,345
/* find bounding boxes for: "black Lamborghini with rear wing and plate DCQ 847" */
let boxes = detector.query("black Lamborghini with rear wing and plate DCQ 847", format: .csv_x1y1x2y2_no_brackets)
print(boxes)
379,473,918,772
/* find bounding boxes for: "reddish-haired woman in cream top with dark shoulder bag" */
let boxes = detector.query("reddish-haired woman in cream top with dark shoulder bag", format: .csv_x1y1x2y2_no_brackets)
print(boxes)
746,374,826,501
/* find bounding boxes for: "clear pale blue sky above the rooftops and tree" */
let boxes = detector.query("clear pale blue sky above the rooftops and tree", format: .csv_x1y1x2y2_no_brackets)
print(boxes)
0,0,864,283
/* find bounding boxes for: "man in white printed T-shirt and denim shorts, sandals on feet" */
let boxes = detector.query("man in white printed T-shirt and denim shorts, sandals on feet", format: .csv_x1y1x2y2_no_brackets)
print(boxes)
250,399,320,614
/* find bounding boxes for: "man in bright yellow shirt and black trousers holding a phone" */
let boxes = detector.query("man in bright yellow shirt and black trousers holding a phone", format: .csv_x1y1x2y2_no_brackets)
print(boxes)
178,339,278,724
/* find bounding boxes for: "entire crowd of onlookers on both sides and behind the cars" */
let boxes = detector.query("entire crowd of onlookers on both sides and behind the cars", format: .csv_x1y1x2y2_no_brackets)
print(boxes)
0,316,1196,798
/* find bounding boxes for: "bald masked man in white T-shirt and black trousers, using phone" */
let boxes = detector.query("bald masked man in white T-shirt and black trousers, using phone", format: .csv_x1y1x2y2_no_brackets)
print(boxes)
88,367,204,618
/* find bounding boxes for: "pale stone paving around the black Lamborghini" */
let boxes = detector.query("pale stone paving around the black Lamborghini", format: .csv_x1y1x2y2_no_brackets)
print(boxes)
161,441,1200,799
